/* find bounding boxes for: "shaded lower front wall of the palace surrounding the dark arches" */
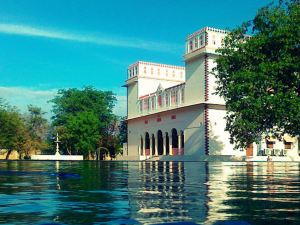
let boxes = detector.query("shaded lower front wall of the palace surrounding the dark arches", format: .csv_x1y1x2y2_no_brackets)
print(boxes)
128,106,205,156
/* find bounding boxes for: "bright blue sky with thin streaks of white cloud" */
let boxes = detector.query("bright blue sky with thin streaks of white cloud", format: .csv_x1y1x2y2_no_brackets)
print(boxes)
0,0,270,118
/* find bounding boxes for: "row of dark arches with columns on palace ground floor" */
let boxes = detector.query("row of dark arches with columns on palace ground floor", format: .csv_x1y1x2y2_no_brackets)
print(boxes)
139,128,184,156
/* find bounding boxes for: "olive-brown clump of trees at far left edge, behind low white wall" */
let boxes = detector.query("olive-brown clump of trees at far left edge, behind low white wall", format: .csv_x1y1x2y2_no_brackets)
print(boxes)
0,99,48,158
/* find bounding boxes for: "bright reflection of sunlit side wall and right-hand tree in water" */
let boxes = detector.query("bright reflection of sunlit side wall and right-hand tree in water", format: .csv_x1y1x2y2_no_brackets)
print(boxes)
204,162,300,224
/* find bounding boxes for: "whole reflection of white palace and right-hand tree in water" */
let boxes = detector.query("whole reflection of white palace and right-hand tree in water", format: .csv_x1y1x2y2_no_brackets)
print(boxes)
128,162,300,224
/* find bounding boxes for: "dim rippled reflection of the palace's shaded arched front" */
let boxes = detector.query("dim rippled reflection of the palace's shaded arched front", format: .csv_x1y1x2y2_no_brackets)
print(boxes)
128,162,207,224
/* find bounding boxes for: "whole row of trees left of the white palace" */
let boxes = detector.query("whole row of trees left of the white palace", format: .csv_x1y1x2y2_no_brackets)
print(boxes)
0,87,127,159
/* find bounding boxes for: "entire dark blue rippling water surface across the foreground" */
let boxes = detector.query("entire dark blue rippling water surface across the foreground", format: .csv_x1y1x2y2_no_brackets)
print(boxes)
0,161,300,225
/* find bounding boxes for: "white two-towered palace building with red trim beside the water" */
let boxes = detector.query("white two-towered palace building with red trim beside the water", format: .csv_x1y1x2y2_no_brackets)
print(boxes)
123,27,298,160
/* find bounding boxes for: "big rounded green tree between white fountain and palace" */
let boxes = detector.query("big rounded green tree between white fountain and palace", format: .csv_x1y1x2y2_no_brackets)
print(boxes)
52,87,116,157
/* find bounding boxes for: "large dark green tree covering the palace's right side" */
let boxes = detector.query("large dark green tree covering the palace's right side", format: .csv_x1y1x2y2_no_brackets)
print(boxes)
215,0,300,148
